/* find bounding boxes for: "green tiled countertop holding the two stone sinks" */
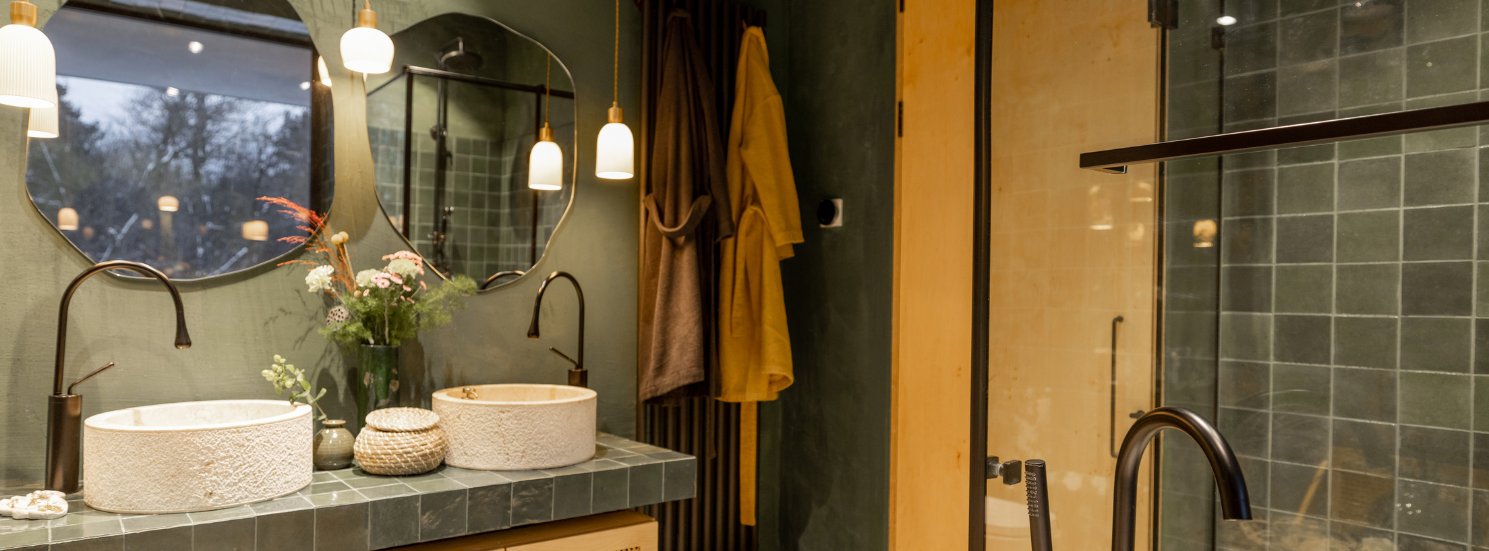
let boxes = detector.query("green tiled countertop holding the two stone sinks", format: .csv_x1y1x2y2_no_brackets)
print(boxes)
0,435,697,551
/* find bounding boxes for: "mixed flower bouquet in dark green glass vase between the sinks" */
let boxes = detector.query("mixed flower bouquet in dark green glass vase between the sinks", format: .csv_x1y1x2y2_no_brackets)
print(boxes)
259,197,476,418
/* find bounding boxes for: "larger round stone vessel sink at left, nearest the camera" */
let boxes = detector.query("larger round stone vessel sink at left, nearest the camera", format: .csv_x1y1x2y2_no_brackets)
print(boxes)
83,401,314,514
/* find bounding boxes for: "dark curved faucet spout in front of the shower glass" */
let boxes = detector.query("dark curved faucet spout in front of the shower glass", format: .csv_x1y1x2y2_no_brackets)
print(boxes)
1112,408,1251,551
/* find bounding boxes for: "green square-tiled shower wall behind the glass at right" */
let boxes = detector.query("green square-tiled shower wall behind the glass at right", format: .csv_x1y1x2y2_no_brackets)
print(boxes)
1161,0,1489,550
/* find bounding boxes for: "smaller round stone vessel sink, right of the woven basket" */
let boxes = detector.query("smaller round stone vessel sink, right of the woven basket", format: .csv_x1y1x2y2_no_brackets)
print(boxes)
433,384,599,471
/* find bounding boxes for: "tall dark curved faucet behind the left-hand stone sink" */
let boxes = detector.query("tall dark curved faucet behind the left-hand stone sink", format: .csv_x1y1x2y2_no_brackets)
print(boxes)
46,261,191,493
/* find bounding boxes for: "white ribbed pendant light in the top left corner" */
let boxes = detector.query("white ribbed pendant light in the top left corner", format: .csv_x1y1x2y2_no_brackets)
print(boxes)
0,0,57,109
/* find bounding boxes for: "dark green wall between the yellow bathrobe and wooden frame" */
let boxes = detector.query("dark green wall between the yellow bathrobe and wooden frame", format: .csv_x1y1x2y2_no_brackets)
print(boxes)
759,0,895,551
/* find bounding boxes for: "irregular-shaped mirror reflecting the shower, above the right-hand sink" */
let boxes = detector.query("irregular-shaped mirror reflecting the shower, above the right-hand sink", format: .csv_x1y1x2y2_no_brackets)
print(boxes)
368,13,575,286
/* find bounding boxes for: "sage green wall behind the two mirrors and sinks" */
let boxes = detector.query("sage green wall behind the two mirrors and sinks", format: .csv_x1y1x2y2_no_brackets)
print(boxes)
0,0,640,485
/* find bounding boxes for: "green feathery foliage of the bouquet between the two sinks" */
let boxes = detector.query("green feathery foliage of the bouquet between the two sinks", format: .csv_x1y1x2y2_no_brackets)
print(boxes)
320,276,476,347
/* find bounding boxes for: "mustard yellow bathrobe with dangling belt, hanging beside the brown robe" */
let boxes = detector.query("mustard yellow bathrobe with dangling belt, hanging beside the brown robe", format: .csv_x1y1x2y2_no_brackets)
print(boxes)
719,27,801,526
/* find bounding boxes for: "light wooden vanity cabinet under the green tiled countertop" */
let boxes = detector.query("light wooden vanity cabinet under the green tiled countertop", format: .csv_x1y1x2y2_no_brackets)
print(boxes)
398,511,657,551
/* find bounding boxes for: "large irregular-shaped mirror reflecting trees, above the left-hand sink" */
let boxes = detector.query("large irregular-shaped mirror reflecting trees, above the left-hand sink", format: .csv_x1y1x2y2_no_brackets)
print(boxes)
25,0,332,280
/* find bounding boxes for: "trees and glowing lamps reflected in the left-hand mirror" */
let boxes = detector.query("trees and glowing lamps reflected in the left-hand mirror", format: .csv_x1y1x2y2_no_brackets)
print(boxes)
27,86,310,277
